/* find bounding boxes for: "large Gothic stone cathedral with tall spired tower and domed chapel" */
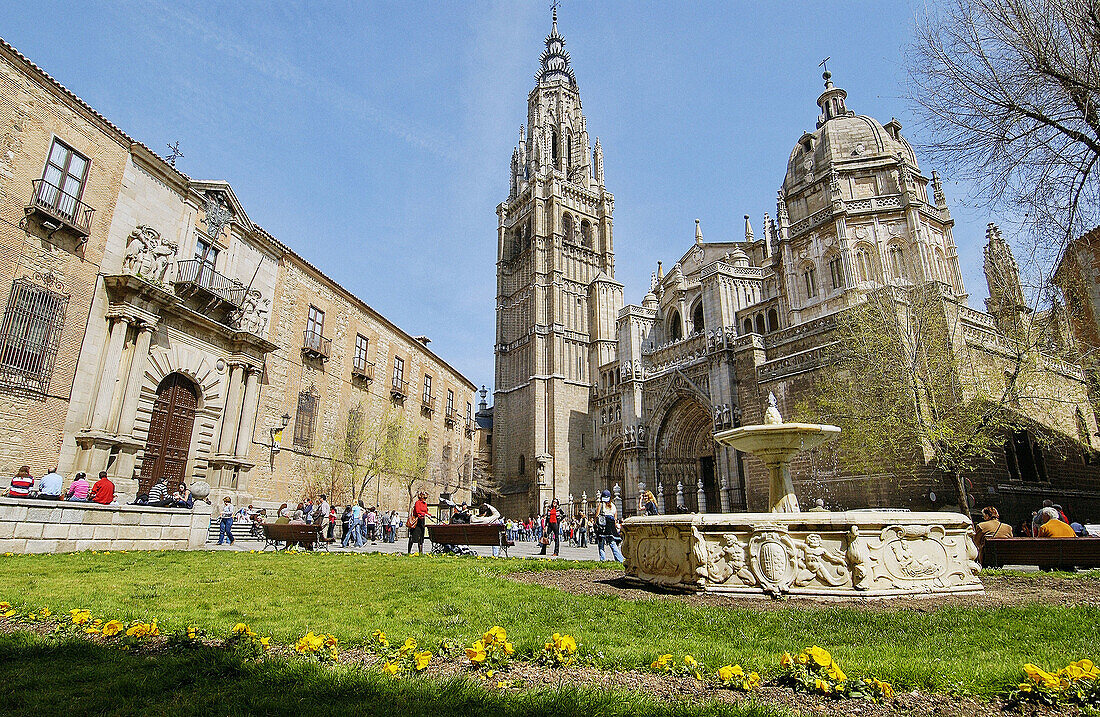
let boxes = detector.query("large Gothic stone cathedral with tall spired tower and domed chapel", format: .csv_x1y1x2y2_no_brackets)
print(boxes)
493,13,1100,525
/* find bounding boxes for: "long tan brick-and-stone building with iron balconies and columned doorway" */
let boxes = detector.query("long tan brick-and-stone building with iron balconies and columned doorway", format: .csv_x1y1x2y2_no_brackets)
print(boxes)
0,37,475,507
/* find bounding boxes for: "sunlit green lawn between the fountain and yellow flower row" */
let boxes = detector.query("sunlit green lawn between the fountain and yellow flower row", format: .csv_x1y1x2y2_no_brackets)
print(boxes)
0,552,1100,694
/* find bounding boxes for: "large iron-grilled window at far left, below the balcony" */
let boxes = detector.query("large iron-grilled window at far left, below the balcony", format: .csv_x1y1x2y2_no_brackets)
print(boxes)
0,279,68,394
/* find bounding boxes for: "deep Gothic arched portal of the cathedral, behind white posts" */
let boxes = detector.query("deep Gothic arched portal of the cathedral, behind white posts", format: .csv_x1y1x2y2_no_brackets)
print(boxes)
655,397,722,512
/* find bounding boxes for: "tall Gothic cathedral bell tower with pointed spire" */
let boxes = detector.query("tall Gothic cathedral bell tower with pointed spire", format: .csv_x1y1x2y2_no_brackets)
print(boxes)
493,9,623,516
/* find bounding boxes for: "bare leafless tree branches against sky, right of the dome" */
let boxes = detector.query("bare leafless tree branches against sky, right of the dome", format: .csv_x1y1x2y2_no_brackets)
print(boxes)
910,0,1100,256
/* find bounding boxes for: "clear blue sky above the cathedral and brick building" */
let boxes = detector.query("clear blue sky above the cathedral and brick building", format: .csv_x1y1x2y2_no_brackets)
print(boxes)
0,0,997,388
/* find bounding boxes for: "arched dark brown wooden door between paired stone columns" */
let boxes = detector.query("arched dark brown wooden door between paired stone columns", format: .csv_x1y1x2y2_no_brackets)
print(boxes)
138,373,199,495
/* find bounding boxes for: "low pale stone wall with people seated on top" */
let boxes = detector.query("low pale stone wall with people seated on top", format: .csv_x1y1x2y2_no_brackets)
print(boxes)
0,498,210,553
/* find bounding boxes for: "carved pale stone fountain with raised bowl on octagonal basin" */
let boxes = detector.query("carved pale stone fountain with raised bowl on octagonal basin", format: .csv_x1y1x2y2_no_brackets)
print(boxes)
623,395,983,598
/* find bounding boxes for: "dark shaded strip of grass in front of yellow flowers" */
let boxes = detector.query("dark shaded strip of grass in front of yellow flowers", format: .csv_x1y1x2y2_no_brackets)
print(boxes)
0,633,781,717
